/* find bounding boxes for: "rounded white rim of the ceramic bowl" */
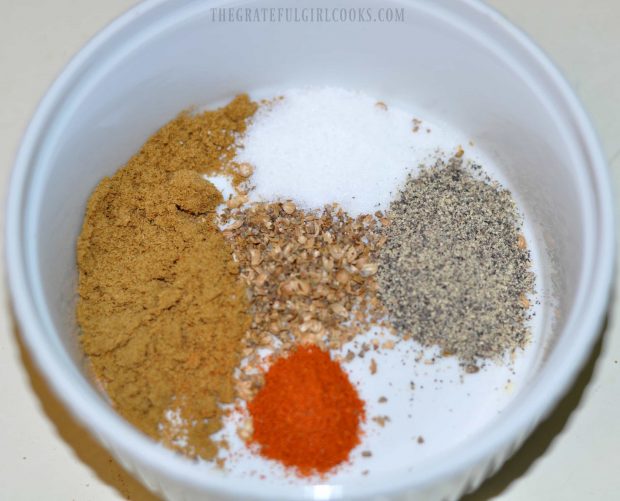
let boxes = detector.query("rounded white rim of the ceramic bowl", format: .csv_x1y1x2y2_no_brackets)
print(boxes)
5,0,615,499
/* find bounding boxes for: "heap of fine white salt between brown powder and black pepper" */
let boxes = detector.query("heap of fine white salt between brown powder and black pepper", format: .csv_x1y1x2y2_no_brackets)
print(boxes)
236,87,440,215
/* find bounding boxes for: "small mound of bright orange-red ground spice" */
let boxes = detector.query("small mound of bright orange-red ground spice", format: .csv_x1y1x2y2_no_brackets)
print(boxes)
248,346,365,476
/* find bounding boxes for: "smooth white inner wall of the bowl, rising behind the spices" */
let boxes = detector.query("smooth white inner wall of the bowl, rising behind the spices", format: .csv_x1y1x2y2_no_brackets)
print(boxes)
10,0,612,498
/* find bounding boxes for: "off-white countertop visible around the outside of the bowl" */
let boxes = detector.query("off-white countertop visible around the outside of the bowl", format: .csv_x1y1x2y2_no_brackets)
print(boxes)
0,0,620,501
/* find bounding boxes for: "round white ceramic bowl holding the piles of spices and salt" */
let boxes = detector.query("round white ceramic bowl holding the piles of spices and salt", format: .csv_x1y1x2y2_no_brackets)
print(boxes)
6,0,614,499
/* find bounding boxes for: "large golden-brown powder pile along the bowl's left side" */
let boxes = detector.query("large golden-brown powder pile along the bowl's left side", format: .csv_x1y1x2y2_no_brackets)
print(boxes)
77,96,256,459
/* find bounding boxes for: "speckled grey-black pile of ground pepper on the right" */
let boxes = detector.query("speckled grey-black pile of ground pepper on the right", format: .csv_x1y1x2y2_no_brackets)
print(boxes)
378,157,534,371
